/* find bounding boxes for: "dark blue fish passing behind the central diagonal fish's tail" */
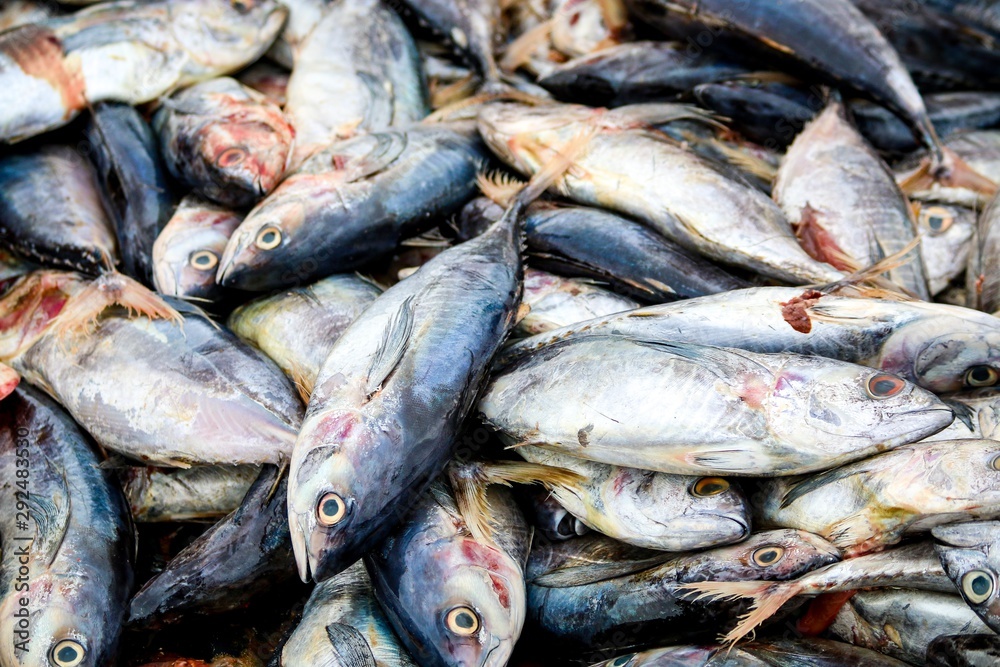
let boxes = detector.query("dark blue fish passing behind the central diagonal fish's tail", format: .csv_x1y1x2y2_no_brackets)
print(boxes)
459,198,748,303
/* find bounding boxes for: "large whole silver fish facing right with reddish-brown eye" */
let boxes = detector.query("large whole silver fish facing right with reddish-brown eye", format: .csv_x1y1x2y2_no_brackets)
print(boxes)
478,335,948,476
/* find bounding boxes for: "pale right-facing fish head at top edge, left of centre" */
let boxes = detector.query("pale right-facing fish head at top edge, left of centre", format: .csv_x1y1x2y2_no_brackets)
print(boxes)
167,0,288,73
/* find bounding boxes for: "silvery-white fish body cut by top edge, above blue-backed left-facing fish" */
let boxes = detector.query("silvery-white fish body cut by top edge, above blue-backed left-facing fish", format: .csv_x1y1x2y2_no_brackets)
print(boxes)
285,0,428,166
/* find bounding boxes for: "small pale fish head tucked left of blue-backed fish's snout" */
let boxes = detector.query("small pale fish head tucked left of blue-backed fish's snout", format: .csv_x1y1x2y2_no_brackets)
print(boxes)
152,195,243,301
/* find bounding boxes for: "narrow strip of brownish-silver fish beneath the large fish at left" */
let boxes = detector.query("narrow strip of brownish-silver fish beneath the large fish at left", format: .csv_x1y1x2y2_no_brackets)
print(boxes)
118,465,260,523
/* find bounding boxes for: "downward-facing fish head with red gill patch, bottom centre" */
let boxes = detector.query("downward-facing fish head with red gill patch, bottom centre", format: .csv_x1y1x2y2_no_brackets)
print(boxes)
400,537,527,667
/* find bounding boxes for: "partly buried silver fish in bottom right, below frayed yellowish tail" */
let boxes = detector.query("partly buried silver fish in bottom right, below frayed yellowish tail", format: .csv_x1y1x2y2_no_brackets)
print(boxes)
830,588,989,665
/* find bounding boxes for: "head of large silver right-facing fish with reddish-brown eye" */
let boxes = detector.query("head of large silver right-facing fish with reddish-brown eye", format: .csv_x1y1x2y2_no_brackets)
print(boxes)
765,356,954,453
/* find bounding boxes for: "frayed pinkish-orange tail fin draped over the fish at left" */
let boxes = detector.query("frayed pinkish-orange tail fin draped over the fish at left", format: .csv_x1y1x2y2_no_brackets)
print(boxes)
50,272,184,334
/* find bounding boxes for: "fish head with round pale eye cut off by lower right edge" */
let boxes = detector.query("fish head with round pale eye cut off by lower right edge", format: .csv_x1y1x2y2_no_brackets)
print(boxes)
931,521,1000,630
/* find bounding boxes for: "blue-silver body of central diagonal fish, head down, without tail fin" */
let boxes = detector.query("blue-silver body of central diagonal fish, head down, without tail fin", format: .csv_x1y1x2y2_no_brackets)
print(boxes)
288,177,522,581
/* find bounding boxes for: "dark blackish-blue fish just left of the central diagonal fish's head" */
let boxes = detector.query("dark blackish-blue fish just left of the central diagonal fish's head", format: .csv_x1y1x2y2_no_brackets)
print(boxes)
128,465,295,626
